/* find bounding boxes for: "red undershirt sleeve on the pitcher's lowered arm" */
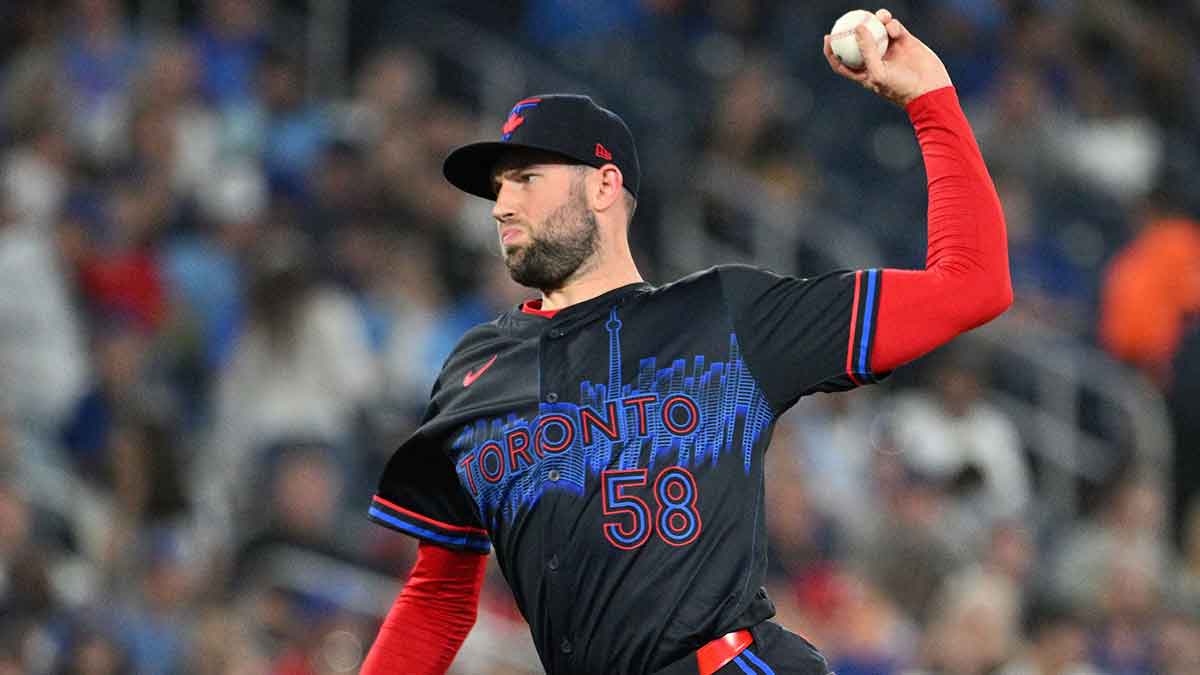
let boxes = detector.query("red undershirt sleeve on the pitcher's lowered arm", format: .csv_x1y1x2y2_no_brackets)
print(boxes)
360,542,487,675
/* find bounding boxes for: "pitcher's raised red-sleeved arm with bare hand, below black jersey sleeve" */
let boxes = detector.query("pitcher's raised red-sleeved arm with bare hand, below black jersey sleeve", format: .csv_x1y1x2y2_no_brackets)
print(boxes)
824,10,1013,372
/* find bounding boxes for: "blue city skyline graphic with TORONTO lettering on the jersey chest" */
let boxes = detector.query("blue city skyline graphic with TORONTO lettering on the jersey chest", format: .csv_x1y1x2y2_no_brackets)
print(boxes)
454,307,775,525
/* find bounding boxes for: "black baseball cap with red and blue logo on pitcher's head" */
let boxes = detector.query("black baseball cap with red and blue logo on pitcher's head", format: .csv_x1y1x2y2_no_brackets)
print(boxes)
442,94,641,199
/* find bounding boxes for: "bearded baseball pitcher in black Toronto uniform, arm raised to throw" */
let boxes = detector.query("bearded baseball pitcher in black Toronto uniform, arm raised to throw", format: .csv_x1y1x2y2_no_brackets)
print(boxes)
362,10,1012,675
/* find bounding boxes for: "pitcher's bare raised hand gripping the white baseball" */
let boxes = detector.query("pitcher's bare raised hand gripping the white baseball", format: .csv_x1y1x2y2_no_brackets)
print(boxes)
824,10,950,107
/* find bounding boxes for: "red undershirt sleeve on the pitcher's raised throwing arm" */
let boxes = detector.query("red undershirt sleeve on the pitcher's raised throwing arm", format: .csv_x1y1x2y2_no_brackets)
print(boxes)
871,86,1013,372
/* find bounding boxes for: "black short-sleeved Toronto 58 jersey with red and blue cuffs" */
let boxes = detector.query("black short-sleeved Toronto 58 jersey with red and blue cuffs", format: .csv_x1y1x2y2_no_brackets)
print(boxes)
370,265,886,675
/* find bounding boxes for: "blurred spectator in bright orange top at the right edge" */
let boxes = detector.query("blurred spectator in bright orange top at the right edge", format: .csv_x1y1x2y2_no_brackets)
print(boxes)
1098,190,1200,387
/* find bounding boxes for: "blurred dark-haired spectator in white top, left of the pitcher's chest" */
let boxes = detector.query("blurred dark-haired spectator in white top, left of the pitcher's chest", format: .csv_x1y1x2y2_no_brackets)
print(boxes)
202,234,379,535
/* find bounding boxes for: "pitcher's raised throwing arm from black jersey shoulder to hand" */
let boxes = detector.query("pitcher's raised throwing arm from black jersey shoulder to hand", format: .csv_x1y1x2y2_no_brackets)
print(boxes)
718,11,1013,412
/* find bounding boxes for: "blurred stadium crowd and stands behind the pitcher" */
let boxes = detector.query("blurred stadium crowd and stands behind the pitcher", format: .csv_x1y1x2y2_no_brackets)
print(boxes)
0,0,1200,675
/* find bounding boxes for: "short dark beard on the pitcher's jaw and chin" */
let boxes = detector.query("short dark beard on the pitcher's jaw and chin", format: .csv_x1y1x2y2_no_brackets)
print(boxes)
504,179,600,292
